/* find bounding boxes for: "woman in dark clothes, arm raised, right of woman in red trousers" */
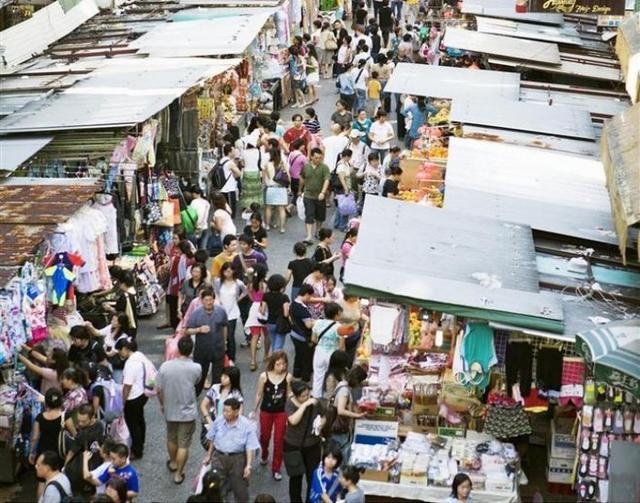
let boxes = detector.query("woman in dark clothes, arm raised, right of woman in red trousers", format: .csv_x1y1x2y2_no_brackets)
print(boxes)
284,381,325,503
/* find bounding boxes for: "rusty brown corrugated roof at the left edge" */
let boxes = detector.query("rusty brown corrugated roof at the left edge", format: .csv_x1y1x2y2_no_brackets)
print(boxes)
0,180,99,278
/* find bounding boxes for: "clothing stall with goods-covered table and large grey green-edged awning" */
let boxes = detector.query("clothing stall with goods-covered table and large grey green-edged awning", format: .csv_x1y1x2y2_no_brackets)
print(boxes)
345,197,631,502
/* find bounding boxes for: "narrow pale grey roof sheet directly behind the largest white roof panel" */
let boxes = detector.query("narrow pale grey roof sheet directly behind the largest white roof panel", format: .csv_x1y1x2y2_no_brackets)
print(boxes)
450,98,595,140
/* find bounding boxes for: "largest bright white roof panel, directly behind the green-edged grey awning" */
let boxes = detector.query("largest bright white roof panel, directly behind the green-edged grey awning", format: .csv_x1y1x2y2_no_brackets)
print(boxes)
444,138,616,244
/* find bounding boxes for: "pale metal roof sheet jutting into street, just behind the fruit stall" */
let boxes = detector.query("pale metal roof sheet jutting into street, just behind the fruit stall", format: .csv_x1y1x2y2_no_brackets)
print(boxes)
385,63,520,101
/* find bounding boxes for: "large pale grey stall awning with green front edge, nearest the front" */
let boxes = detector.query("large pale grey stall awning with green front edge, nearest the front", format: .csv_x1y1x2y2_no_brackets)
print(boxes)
345,196,563,333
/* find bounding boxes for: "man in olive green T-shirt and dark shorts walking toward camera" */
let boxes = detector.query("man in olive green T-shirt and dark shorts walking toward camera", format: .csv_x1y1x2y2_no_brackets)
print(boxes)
300,148,331,245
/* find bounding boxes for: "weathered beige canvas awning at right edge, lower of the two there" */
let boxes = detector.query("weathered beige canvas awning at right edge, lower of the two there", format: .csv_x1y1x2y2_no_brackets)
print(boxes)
600,103,640,262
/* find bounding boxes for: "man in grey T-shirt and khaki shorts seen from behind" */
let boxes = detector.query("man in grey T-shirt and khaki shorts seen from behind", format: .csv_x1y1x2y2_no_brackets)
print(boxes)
156,337,202,484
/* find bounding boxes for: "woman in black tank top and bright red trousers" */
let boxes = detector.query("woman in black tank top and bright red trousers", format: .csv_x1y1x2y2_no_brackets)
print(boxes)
253,351,292,480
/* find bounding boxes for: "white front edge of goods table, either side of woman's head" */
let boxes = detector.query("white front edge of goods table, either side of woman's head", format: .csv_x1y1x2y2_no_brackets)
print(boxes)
358,479,520,503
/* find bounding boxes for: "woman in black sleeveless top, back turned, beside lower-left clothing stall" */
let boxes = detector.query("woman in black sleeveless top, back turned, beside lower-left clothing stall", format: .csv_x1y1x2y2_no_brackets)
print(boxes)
29,388,64,497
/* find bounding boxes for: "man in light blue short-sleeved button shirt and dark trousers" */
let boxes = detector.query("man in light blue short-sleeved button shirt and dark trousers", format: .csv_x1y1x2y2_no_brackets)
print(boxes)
203,398,260,501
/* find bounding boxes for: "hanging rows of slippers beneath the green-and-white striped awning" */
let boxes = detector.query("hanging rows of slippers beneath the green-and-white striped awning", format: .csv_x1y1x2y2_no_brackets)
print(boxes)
577,380,640,501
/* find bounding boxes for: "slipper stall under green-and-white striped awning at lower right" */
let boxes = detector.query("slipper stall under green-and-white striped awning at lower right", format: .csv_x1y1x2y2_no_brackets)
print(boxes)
576,319,640,502
